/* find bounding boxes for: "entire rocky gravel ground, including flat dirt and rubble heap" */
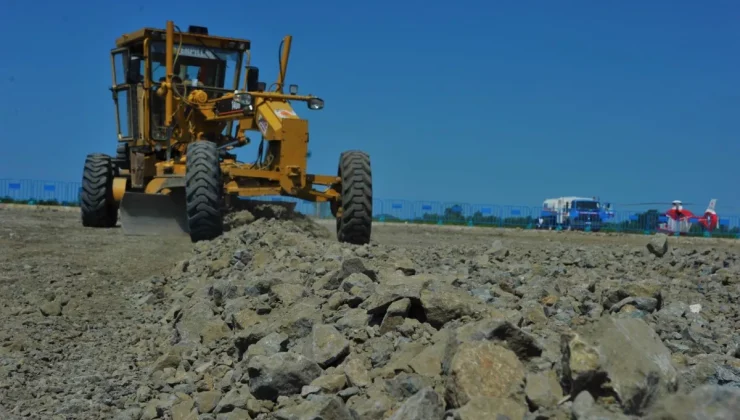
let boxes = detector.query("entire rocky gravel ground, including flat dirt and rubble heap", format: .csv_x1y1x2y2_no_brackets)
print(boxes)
0,209,740,420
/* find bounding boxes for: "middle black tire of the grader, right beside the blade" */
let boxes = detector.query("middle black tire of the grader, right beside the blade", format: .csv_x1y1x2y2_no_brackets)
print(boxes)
185,141,224,242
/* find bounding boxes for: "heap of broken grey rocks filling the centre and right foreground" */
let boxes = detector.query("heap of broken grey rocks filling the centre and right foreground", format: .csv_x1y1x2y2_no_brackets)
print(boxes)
126,218,740,420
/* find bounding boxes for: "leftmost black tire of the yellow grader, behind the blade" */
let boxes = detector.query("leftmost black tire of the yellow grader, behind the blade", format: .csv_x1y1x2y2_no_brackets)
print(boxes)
80,153,118,228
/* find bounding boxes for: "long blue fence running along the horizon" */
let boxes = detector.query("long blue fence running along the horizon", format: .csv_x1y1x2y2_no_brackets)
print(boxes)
0,179,740,239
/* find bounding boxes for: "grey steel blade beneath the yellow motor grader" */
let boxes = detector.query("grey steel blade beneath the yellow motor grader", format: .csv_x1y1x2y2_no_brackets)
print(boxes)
120,192,189,236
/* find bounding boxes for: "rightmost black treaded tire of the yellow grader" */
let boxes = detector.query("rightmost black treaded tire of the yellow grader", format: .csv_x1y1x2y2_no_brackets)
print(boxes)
337,150,373,245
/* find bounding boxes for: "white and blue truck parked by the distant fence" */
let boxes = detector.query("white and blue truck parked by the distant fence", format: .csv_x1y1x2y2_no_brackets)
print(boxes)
537,196,614,232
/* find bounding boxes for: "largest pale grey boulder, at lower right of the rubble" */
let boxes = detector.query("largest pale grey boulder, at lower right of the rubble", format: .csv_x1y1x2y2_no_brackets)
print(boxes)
562,317,678,415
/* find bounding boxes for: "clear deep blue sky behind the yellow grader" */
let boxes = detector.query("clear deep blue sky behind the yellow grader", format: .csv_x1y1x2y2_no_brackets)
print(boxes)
0,0,740,213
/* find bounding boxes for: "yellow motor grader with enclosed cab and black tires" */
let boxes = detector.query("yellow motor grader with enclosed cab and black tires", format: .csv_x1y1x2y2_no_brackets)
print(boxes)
80,21,372,244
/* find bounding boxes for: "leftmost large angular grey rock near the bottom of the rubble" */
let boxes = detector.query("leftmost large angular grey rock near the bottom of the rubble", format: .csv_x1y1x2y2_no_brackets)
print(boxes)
247,352,323,401
